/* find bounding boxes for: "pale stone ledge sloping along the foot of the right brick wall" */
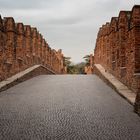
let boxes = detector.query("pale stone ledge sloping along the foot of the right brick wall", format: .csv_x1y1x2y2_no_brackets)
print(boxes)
94,64,136,105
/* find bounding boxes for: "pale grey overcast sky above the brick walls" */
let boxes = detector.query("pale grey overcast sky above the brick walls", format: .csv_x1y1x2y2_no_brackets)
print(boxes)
0,0,140,63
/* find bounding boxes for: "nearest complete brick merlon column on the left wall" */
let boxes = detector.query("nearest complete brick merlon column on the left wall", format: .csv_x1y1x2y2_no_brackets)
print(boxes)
3,17,16,77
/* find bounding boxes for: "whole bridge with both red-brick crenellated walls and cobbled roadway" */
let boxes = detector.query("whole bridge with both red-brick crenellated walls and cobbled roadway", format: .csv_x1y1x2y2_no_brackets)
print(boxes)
0,6,140,140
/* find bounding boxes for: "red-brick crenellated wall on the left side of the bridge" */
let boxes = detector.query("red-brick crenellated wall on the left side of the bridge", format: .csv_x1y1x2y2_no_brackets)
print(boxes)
0,16,66,81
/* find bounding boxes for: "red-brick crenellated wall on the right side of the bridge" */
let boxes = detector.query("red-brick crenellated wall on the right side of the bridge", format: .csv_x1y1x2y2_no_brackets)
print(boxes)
94,5,140,114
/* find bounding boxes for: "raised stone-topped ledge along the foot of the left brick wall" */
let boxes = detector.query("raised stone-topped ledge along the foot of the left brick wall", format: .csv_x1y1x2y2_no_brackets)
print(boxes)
0,65,55,92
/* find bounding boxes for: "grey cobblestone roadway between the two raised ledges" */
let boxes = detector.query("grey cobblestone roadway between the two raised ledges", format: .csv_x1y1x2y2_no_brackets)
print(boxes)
0,75,140,140
